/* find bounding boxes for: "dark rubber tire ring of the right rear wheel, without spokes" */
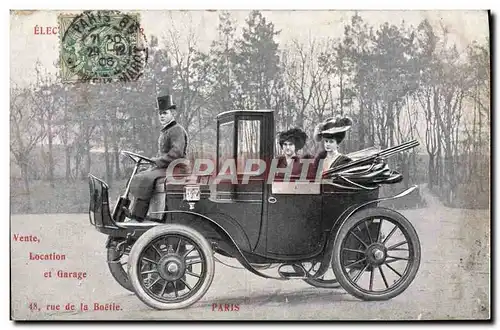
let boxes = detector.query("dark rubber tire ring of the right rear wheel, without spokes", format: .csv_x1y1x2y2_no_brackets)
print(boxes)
332,207,421,301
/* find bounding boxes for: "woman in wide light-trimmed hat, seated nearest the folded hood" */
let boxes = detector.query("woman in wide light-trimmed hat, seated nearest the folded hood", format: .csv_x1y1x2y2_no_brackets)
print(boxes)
312,117,352,176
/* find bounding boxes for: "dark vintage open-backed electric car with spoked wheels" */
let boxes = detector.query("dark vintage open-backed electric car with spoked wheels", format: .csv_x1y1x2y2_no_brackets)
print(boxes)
89,110,420,309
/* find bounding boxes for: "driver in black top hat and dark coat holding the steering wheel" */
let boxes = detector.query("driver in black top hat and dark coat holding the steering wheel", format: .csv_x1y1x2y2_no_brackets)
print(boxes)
130,95,188,221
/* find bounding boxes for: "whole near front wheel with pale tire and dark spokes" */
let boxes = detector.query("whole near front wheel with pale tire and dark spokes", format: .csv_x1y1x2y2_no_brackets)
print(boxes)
128,225,215,310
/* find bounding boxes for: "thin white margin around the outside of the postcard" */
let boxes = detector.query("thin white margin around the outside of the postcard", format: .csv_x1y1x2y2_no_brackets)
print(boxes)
0,0,500,329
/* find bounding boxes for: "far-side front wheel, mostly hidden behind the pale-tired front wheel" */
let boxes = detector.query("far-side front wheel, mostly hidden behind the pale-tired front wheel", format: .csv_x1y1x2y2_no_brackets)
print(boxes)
107,239,134,292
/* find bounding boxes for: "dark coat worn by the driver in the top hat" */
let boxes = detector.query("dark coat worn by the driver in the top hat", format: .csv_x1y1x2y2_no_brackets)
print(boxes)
130,120,188,200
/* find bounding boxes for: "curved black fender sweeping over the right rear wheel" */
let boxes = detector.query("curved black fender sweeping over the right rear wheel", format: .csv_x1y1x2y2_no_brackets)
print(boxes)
313,185,417,278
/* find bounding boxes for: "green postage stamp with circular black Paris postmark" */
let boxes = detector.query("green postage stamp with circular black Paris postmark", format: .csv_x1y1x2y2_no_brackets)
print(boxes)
60,11,148,82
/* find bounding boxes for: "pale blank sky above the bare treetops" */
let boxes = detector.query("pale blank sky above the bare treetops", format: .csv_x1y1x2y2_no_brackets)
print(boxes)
9,10,489,86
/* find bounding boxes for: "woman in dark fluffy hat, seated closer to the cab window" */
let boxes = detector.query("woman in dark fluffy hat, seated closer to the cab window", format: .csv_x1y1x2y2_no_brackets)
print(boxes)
276,128,312,178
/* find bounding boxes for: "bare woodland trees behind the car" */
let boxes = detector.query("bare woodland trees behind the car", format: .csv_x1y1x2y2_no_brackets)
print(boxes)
10,11,491,213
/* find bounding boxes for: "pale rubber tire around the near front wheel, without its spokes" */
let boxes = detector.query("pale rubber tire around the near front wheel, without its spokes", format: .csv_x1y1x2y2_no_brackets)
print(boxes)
127,224,215,310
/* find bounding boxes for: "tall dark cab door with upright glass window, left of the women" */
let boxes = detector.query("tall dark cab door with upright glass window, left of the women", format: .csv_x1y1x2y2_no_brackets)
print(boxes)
211,111,265,252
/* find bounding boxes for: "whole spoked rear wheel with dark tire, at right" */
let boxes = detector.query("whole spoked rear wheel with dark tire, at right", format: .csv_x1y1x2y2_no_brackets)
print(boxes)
332,207,421,300
